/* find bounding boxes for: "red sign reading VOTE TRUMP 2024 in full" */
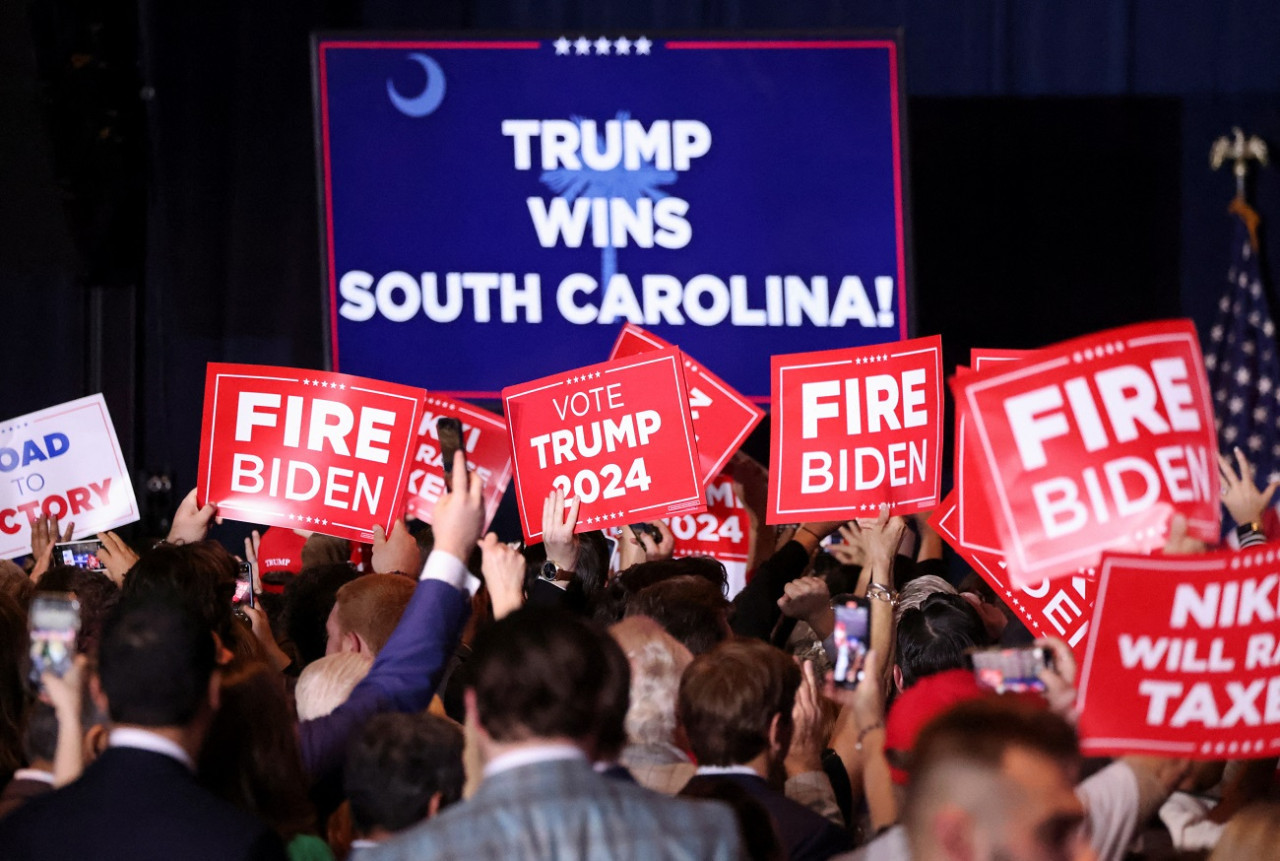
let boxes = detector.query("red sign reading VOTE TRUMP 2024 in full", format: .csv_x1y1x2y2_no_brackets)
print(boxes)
502,348,707,542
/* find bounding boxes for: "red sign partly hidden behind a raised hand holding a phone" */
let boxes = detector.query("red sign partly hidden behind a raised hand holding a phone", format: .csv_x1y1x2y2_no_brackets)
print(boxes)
404,394,511,530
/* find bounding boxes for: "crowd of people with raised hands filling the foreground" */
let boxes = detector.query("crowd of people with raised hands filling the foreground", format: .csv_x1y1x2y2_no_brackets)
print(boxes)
0,442,1280,861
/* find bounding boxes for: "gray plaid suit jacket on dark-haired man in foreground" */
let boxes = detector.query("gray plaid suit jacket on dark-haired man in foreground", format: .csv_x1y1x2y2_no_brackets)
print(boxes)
361,760,742,861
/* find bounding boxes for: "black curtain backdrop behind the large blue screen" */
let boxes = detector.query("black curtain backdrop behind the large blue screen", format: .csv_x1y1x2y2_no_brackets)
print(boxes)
0,0,1280,534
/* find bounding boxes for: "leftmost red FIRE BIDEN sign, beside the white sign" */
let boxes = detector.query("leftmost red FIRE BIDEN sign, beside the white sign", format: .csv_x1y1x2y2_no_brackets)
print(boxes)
196,363,426,541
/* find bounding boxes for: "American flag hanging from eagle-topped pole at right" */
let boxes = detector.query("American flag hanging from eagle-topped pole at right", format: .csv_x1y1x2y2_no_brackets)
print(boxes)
1204,214,1280,506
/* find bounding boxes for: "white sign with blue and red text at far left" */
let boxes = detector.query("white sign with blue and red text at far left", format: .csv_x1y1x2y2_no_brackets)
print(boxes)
0,394,138,559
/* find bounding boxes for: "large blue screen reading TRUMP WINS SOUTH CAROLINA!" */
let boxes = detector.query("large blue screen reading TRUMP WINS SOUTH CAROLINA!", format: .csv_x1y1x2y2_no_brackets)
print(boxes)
315,35,908,398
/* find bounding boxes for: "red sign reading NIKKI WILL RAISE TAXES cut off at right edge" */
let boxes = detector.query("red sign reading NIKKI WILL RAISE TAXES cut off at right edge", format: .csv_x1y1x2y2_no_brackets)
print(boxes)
1078,544,1280,760
